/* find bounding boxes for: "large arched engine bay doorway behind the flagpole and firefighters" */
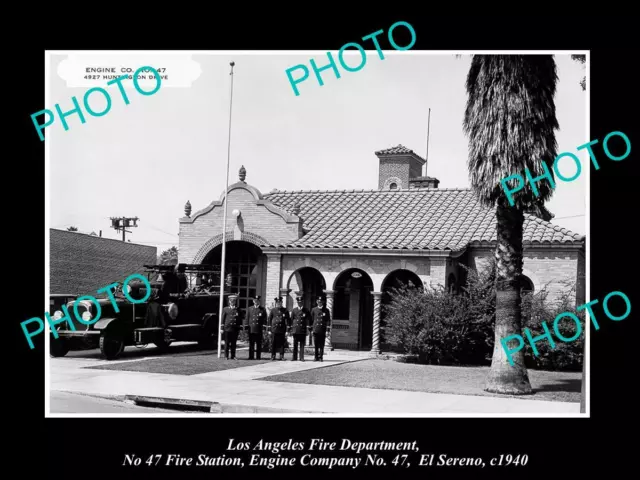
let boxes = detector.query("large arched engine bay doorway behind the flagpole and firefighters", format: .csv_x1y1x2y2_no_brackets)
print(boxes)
202,241,264,309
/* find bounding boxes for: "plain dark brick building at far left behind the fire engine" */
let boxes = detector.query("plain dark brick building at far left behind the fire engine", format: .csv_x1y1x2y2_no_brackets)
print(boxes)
49,228,158,297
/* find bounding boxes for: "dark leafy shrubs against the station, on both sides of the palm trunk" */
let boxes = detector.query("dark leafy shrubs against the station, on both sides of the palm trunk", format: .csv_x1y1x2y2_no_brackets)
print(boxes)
384,262,584,371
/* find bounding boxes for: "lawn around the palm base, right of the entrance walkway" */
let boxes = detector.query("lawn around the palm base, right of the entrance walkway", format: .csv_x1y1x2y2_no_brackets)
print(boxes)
260,359,582,402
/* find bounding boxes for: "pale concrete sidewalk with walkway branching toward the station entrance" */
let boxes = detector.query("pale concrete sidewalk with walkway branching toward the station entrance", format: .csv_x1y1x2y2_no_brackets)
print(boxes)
50,344,580,416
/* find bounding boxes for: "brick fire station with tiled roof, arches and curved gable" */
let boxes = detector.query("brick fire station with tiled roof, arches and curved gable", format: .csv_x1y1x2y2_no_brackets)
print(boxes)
179,145,585,352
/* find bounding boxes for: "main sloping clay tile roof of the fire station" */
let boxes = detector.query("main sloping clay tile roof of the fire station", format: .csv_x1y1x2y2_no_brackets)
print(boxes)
264,188,584,250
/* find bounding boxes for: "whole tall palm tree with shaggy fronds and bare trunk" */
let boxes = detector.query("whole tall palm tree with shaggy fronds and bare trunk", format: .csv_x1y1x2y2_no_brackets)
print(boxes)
464,55,559,395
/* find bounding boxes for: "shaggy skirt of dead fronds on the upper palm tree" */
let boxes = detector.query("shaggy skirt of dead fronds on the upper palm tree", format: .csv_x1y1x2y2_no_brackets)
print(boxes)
463,55,559,210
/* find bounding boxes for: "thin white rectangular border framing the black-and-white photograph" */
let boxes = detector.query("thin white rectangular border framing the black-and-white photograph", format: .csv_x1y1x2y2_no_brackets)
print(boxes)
43,49,591,419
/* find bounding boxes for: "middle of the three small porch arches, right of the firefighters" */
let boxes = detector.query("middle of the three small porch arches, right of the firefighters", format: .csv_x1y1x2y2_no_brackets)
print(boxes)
331,268,373,350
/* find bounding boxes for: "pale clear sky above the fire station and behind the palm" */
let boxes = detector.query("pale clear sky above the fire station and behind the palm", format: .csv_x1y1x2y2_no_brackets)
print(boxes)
45,50,591,254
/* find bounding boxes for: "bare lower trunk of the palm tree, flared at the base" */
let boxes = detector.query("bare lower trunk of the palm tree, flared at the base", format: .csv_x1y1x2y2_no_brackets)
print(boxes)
485,202,532,395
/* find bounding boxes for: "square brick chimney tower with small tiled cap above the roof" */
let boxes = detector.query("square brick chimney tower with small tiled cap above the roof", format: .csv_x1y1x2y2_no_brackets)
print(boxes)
375,145,427,190
